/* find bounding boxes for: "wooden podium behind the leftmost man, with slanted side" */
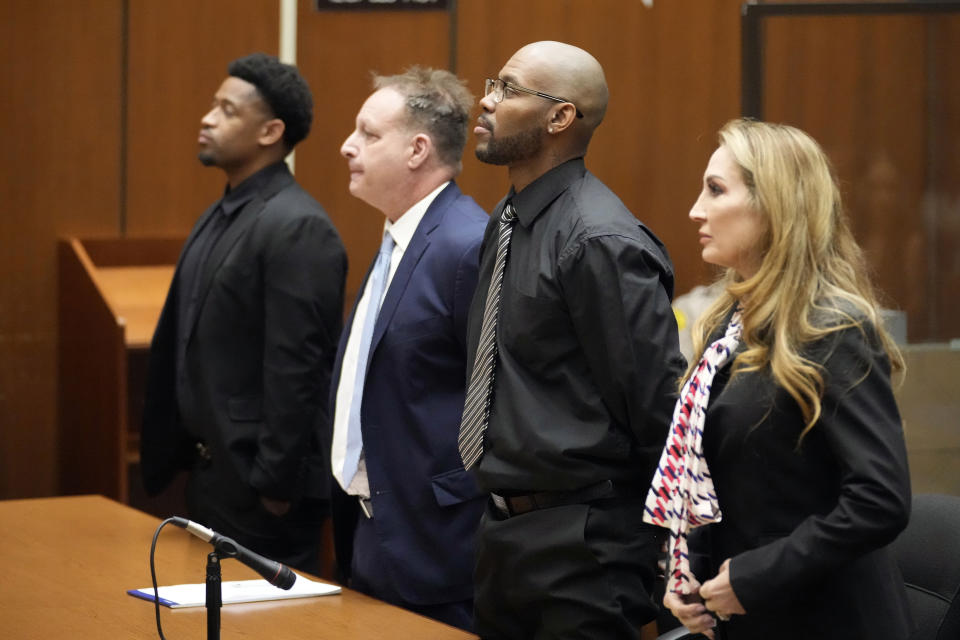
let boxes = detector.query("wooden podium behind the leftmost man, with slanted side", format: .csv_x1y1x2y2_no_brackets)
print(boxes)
57,237,185,511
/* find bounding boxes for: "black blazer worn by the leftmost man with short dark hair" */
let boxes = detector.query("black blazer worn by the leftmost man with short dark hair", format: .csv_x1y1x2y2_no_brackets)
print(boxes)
141,163,347,507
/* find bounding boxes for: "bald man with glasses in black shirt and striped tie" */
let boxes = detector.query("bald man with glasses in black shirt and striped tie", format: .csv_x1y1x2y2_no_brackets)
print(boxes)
461,42,683,638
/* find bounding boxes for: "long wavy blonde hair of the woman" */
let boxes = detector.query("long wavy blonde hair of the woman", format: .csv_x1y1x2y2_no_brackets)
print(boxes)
684,119,904,445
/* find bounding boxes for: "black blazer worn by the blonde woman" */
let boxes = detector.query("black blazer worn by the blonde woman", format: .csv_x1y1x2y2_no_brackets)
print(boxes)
698,318,911,640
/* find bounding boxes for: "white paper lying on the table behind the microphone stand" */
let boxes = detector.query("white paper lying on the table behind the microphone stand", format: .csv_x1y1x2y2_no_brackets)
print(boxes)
127,574,340,609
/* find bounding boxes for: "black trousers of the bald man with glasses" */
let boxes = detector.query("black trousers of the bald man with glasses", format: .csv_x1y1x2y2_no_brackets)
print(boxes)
474,497,667,640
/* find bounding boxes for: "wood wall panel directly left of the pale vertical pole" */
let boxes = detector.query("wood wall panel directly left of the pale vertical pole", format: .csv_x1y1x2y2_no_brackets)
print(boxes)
121,0,280,236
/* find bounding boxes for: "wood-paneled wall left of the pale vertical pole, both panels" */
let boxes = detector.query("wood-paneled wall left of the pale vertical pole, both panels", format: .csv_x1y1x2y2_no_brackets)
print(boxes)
0,0,279,498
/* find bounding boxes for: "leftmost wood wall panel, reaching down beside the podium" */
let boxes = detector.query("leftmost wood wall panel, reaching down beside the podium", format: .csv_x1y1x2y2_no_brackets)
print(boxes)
0,0,122,498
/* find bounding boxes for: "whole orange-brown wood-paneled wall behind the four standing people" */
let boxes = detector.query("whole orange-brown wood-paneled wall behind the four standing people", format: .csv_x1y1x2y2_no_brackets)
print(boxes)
0,0,960,498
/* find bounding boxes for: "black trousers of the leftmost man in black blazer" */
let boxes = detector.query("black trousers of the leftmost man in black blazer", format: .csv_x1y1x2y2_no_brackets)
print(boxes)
187,464,329,575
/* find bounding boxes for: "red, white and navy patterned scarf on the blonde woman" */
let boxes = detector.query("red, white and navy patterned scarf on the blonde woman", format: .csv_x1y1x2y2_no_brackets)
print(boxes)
643,306,742,594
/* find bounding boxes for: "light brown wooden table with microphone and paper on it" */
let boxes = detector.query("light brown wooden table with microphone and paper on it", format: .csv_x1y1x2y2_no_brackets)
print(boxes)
0,496,475,640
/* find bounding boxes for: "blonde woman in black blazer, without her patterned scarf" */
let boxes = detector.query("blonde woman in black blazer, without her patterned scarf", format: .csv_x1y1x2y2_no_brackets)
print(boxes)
664,120,911,640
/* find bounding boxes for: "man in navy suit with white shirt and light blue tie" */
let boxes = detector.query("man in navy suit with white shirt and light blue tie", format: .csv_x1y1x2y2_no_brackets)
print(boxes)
331,67,487,629
